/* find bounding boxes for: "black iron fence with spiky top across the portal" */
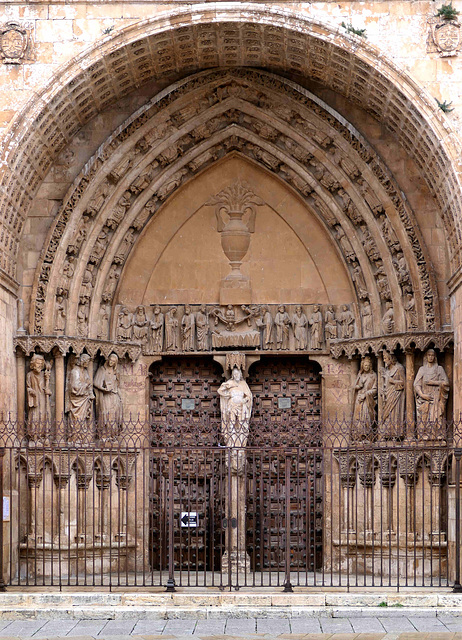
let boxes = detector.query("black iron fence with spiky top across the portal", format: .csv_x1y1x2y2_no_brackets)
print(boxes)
0,414,462,591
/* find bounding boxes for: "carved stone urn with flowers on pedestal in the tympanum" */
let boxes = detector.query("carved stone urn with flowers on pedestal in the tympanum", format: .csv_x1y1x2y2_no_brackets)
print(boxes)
207,180,264,304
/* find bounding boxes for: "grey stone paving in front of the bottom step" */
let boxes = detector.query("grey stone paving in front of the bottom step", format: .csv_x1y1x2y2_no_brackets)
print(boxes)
0,614,462,640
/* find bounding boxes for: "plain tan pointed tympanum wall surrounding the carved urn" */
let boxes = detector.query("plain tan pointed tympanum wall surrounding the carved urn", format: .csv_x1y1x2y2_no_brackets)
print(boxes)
116,155,354,307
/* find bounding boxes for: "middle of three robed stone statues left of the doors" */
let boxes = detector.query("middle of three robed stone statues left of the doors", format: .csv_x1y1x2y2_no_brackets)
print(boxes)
66,353,95,436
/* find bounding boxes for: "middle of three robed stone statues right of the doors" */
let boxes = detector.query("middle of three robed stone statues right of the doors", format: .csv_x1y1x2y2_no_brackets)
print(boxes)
378,351,406,439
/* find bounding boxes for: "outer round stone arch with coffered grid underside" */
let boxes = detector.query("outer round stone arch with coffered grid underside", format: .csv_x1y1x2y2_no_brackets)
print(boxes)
0,4,462,282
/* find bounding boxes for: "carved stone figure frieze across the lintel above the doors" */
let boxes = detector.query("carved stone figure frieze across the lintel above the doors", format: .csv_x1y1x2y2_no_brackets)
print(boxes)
115,304,356,353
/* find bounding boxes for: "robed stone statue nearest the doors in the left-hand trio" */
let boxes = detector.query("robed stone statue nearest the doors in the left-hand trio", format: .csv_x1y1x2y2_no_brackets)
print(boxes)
93,353,122,437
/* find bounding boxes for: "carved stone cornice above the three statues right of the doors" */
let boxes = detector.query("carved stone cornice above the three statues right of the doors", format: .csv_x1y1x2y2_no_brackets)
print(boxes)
330,331,454,360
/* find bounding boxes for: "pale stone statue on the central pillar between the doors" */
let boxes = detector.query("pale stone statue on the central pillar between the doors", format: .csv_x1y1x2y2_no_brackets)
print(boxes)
218,367,252,447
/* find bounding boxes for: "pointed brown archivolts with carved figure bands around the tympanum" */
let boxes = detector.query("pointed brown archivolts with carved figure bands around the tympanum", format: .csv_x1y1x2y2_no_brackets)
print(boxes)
31,69,439,338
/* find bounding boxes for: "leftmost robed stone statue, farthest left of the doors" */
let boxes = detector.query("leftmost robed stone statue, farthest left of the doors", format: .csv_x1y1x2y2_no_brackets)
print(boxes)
26,353,51,437
